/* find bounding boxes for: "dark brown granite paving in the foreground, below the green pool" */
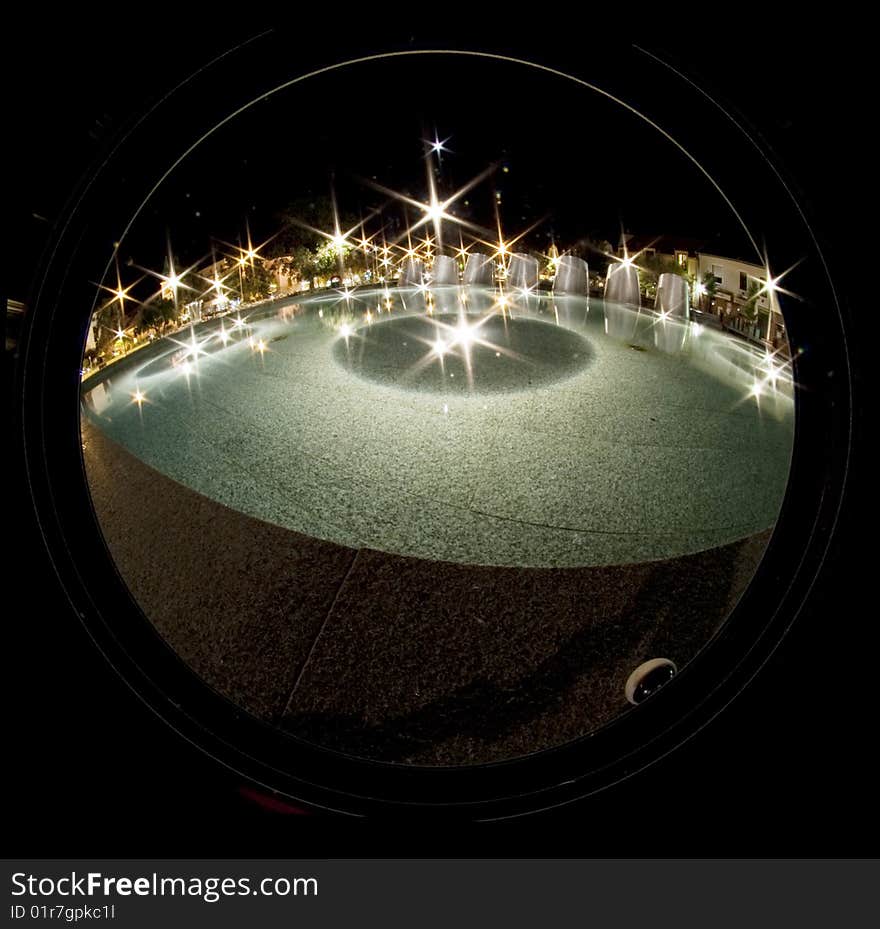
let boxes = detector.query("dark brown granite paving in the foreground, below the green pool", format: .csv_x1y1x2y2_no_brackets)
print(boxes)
83,419,767,764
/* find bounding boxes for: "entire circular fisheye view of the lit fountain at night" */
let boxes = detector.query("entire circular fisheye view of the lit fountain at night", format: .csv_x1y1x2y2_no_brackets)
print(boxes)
80,54,796,767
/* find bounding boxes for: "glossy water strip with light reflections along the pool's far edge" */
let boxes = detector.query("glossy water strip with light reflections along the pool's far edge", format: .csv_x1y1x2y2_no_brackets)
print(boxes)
84,286,793,415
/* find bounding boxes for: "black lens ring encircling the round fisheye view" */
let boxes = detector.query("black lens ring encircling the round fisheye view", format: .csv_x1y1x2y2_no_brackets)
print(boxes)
12,37,851,818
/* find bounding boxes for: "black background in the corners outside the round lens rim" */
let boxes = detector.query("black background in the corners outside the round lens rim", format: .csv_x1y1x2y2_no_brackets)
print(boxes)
4,20,877,856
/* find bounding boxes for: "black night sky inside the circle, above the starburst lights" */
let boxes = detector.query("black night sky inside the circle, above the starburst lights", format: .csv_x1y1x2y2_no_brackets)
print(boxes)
131,51,744,260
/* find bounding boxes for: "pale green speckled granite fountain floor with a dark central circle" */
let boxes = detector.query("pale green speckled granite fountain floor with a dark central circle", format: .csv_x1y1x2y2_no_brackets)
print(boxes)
86,288,792,567
